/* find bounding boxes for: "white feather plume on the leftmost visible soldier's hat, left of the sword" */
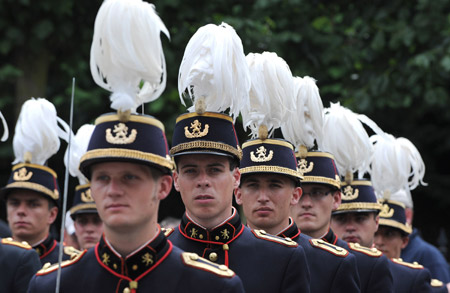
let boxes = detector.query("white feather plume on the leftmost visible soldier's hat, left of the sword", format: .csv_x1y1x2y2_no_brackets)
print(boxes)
13,98,69,165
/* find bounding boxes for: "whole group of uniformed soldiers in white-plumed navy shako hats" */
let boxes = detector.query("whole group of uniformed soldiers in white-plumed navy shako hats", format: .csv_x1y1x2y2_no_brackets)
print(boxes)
0,0,450,292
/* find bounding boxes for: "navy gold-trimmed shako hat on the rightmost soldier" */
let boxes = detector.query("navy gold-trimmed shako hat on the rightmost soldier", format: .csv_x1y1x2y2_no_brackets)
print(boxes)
379,199,412,234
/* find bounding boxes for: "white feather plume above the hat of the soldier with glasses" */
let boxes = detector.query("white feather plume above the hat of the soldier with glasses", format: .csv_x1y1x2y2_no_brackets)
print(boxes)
281,76,323,149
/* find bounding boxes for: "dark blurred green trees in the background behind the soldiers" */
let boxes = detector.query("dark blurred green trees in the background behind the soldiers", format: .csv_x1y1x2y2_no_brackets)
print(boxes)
0,0,450,259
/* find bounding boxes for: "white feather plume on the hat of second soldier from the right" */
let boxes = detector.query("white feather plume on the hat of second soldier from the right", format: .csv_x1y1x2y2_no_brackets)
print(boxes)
322,103,382,178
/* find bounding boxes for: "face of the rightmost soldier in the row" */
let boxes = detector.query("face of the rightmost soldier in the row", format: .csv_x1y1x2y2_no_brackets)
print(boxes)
375,226,409,258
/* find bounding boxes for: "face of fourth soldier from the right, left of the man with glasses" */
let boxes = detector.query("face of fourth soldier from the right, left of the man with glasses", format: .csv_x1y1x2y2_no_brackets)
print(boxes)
235,174,301,234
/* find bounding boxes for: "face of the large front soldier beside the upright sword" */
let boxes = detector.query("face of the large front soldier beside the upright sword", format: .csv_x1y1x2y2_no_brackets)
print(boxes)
91,162,172,236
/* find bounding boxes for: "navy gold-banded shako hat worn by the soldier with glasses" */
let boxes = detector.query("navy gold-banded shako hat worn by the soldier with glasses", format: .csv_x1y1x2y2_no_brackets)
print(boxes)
295,150,341,189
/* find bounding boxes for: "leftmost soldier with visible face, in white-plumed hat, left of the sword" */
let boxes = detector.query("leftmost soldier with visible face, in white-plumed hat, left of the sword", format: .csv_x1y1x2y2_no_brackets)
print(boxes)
1,99,76,265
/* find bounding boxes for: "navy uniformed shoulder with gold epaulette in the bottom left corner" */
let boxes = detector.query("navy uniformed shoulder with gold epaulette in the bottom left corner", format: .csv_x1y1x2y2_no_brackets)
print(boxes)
0,238,41,293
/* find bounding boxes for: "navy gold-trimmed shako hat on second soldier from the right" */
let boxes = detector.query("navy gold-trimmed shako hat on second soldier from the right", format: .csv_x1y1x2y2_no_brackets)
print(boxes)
333,180,381,214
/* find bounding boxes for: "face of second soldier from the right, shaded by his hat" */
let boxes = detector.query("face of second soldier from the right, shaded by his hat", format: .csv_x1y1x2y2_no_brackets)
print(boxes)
331,212,379,247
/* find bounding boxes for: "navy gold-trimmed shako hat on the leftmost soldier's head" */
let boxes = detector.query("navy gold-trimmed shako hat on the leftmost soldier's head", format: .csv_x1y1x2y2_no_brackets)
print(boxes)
1,163,59,206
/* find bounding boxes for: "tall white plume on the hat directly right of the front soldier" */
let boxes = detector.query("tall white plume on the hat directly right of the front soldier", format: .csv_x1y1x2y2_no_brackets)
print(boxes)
178,23,250,118
